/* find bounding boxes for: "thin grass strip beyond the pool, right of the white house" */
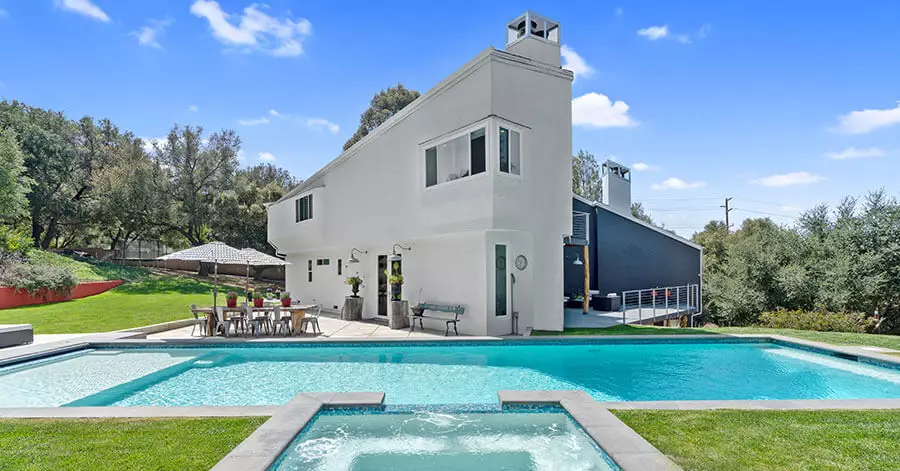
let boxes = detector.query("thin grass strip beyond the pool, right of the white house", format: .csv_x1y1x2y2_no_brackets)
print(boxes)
532,325,900,350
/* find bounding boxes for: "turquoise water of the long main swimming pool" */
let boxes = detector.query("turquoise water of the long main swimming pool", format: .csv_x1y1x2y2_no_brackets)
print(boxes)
0,342,900,407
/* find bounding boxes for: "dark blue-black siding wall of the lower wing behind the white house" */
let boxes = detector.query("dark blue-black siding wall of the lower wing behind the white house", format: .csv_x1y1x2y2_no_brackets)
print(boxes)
564,200,700,294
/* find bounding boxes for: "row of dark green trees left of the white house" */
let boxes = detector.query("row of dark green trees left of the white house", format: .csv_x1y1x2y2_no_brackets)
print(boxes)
0,97,297,253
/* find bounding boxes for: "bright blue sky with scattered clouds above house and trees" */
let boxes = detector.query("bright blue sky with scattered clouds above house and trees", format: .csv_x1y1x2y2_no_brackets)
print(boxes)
0,0,900,236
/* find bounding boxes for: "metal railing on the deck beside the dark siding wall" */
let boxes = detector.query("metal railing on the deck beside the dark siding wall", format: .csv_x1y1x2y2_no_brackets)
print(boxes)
622,284,703,325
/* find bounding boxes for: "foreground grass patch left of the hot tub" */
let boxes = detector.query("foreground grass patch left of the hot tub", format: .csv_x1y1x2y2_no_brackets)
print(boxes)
0,417,266,471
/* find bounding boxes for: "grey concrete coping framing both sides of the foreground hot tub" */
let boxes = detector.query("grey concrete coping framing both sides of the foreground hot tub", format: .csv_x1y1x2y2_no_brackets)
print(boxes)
212,391,681,471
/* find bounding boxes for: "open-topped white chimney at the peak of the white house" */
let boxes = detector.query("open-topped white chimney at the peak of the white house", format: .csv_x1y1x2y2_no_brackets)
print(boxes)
506,11,562,67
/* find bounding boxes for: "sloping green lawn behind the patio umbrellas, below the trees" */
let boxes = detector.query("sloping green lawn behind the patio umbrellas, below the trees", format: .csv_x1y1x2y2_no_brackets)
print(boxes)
0,275,243,334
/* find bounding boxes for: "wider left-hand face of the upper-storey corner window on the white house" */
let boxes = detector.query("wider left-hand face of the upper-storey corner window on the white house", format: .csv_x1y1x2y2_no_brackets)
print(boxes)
425,128,487,187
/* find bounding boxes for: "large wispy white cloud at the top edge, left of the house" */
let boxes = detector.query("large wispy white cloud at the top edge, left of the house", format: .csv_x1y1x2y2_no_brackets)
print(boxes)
191,0,312,57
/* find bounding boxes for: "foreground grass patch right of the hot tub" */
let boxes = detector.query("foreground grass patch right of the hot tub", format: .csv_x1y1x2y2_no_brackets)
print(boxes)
613,410,900,471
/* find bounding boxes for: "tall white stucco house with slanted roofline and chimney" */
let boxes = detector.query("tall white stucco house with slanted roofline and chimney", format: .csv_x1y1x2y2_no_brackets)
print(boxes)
268,13,573,335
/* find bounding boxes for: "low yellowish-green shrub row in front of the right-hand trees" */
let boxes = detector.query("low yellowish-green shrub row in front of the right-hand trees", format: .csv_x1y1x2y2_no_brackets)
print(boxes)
759,309,875,333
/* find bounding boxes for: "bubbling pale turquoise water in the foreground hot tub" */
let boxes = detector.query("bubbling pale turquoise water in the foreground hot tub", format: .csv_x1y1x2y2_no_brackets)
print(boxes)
270,412,618,471
